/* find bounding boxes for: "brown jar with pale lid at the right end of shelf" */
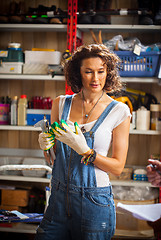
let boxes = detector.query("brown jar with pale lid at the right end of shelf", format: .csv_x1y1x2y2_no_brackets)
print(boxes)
150,104,161,130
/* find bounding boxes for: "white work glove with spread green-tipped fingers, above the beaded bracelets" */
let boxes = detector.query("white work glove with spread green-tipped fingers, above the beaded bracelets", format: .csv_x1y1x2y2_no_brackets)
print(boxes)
51,120,90,155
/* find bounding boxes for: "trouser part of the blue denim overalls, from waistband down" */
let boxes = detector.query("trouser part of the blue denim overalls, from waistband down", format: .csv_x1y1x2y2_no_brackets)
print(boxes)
36,180,115,240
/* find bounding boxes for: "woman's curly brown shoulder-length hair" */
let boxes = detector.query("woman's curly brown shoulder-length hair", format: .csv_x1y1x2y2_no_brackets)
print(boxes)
64,44,122,93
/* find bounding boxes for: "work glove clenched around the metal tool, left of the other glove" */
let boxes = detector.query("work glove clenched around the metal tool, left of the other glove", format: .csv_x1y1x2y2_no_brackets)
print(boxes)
38,130,55,151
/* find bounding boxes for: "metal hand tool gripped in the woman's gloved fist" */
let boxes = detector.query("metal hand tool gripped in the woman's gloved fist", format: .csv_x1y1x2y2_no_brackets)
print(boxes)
34,114,55,165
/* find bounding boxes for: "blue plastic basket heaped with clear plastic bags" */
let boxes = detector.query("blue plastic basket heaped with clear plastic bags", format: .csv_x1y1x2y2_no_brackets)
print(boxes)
103,35,161,77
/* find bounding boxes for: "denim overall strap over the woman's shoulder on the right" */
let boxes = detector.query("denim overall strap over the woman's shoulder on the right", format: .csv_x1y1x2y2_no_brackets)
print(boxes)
90,100,118,132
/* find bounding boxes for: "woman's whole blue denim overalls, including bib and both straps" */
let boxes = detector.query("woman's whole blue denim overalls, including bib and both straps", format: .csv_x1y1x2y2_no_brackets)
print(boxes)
36,96,117,240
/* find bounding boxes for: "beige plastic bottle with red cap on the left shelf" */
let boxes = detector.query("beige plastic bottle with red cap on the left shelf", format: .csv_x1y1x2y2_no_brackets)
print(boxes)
18,95,27,126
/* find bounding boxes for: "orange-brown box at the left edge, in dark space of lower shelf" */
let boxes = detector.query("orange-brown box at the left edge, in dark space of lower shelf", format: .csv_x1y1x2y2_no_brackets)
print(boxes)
1,189,29,207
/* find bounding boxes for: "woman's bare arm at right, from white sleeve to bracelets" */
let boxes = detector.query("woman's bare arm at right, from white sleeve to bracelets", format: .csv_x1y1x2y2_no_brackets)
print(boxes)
93,117,130,175
